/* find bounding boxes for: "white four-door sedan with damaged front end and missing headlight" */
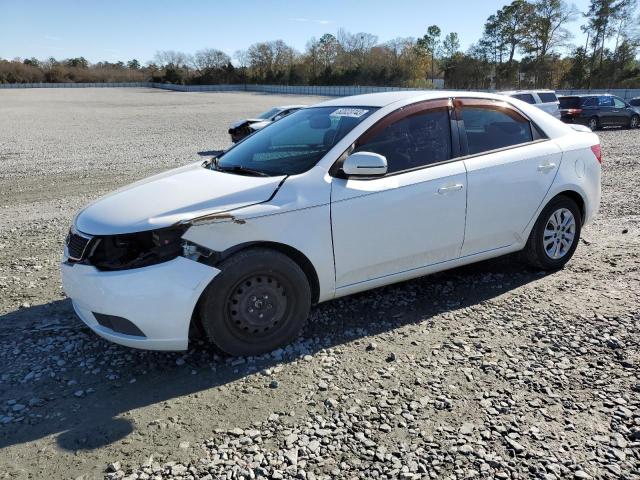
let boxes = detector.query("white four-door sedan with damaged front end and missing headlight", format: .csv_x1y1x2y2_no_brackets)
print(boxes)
62,91,601,355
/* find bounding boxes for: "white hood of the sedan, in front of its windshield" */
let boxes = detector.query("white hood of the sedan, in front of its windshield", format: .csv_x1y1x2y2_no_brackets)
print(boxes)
75,162,284,235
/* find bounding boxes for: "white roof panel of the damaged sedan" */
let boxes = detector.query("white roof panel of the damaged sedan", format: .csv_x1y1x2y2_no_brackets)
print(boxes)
314,90,520,107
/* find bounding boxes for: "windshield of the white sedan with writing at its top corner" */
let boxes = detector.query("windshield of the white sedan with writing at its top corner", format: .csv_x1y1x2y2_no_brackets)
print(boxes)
211,107,376,176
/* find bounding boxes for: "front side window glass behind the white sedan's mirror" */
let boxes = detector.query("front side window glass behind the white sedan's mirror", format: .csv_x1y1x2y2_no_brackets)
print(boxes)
355,108,451,173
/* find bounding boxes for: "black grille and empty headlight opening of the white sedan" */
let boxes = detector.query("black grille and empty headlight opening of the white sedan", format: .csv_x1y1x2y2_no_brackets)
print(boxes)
67,226,188,270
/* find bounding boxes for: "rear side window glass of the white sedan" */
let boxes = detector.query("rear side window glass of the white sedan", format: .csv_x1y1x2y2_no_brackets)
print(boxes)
461,105,533,155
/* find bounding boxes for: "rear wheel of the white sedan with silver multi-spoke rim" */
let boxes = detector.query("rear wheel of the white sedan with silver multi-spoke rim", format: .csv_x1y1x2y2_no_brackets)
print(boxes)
523,195,582,270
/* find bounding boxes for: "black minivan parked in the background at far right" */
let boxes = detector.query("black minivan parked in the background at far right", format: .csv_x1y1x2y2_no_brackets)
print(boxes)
560,93,640,130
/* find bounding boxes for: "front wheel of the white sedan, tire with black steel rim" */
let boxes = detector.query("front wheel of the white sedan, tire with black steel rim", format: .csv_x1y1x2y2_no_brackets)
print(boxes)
200,248,311,356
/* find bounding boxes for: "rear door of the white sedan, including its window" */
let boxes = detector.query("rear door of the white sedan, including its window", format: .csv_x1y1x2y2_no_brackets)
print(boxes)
455,99,562,256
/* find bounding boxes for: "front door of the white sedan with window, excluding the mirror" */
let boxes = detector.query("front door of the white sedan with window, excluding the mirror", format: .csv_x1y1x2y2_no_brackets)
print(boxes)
331,100,467,289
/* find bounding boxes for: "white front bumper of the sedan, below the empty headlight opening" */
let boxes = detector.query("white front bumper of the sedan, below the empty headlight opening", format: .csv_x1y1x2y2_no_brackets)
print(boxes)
61,257,220,350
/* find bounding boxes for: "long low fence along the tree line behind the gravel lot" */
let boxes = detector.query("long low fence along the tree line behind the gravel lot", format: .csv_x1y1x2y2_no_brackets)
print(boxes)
0,82,640,100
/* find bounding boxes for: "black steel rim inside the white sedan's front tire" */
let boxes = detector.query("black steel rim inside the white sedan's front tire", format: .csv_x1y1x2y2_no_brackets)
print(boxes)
226,273,291,341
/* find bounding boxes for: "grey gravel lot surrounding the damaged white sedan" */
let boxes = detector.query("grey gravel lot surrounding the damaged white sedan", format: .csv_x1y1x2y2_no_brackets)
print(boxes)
0,89,640,480
